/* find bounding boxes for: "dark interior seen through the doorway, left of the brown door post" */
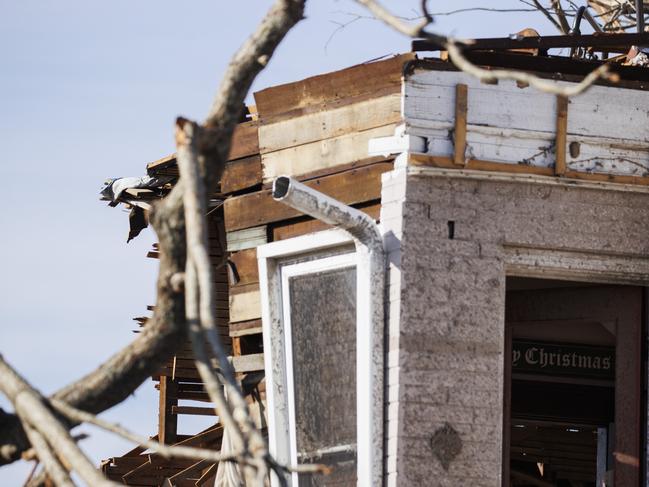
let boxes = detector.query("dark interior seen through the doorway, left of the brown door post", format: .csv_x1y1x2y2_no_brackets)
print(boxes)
504,278,616,487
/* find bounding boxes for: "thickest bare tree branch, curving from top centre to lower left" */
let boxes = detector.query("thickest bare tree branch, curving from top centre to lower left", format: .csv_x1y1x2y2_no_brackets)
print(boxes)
0,0,305,472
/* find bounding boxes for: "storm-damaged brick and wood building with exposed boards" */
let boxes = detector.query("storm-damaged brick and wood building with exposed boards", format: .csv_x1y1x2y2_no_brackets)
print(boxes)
98,34,649,487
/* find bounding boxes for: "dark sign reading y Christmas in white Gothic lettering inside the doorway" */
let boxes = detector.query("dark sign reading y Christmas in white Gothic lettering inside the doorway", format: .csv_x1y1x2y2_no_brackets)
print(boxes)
512,340,615,379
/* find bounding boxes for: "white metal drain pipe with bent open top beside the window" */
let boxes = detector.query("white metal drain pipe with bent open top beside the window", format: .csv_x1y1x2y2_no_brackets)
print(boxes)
273,176,385,487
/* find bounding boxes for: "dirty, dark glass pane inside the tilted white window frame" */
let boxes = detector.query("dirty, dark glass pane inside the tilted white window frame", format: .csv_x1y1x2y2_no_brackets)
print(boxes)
289,267,356,486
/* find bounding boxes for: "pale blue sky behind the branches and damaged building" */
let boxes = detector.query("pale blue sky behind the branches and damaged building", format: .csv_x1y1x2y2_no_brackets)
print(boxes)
0,0,553,487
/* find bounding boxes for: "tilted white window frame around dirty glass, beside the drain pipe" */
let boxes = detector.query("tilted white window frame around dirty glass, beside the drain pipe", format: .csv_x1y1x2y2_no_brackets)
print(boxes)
257,230,372,487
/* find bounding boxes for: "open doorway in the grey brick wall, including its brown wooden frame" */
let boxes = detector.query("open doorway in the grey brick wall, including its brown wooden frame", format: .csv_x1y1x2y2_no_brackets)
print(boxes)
503,278,642,487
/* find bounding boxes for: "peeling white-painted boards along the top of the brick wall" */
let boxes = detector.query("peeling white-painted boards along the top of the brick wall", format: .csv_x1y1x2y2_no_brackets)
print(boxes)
404,70,649,176
